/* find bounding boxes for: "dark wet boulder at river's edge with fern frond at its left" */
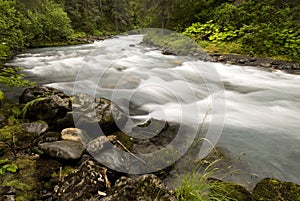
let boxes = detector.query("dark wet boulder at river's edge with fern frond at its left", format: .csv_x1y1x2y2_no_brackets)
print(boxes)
20,87,71,124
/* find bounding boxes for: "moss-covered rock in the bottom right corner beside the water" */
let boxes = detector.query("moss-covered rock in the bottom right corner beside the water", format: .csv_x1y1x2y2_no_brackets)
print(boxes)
252,178,300,201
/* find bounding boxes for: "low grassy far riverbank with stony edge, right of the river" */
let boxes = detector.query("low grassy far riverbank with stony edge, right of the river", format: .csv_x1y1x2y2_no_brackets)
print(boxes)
143,30,300,74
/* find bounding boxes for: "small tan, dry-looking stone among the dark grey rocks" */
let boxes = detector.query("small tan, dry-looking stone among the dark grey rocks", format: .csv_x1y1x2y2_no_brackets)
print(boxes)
61,128,90,145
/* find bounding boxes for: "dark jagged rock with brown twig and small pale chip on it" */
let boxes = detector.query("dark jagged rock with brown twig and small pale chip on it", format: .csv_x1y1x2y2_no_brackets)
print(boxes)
55,160,111,201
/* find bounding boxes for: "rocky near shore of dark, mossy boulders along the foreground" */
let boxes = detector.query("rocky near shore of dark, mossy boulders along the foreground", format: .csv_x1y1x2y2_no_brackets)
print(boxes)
0,85,300,201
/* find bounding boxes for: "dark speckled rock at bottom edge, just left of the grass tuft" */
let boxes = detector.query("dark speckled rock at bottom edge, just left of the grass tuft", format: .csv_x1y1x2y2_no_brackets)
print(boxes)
103,175,177,201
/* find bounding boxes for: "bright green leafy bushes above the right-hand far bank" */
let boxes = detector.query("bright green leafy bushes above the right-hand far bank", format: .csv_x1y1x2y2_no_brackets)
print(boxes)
184,0,300,60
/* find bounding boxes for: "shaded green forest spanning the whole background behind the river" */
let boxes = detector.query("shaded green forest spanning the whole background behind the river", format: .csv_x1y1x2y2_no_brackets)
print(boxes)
0,0,300,61
